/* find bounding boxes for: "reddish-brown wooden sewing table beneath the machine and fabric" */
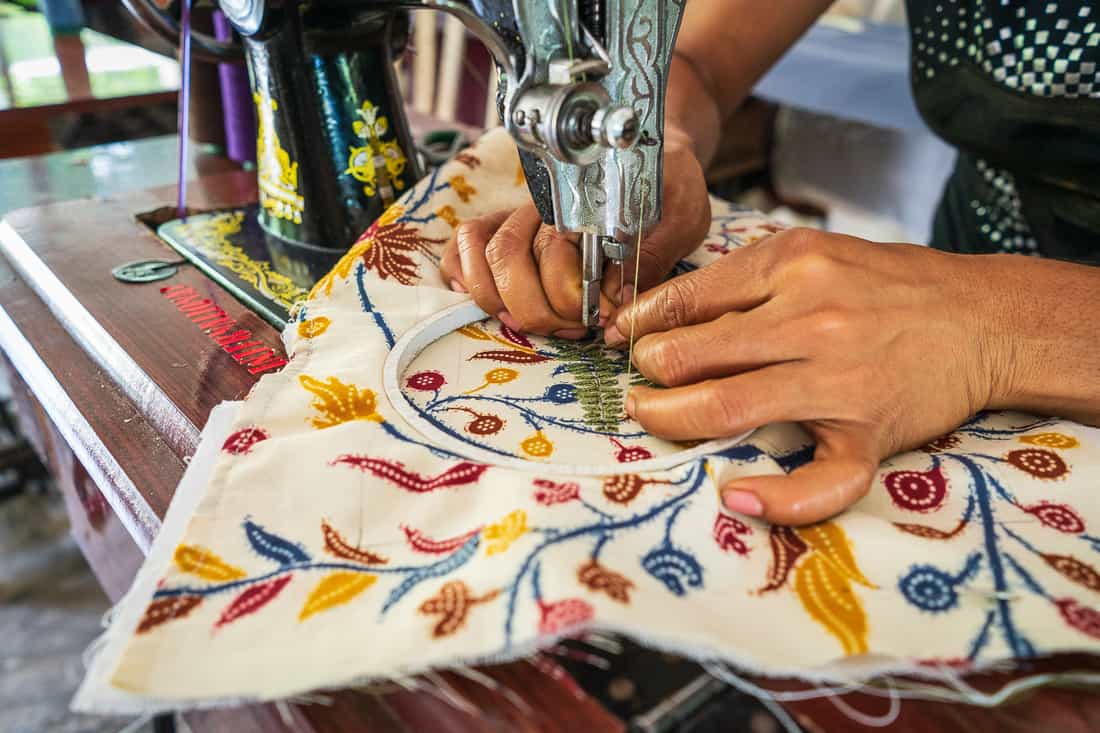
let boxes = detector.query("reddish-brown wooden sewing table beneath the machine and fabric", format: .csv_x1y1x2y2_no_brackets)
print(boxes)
0,139,1100,733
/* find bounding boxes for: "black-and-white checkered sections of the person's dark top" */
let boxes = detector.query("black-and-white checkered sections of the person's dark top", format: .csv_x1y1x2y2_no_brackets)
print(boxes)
909,0,1100,253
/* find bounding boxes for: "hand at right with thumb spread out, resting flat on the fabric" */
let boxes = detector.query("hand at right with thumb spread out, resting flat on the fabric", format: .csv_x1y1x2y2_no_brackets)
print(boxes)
608,229,1022,524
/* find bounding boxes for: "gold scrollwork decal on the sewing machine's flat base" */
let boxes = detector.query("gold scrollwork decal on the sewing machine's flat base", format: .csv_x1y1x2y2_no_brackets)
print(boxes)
173,211,308,310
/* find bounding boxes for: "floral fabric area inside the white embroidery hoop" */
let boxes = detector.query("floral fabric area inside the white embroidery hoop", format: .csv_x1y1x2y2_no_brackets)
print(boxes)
398,311,739,473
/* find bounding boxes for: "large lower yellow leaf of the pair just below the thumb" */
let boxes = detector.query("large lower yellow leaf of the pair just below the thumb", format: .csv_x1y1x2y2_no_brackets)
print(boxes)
794,553,867,655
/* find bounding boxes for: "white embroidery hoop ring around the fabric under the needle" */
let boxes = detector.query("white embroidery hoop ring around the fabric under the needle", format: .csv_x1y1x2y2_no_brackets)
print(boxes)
383,302,751,475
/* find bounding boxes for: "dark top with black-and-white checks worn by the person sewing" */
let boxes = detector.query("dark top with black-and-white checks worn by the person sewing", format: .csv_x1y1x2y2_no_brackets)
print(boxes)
909,0,1100,262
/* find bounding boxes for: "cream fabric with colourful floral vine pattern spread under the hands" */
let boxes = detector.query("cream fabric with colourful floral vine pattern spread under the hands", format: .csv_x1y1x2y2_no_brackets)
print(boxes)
81,132,1100,704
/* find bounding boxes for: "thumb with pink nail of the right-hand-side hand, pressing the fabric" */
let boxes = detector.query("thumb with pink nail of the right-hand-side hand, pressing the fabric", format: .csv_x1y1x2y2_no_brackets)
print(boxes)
722,437,879,525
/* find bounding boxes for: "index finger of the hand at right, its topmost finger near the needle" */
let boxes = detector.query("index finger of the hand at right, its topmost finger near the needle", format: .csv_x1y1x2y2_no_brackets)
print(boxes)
605,236,771,346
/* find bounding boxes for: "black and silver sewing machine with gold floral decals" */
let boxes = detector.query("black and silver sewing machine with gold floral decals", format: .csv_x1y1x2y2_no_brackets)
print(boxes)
125,0,683,326
